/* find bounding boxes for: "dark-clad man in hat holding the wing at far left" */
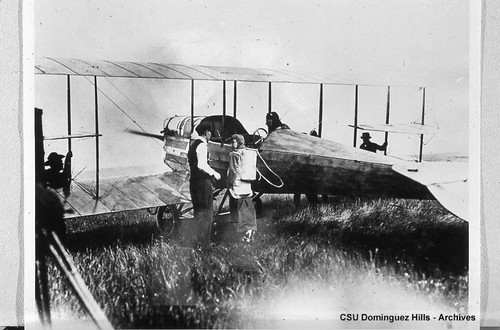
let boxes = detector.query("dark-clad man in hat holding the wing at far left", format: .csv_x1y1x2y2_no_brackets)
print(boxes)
43,151,73,197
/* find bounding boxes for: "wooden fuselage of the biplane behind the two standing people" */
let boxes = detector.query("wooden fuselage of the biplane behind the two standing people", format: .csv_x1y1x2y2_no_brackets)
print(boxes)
164,117,433,199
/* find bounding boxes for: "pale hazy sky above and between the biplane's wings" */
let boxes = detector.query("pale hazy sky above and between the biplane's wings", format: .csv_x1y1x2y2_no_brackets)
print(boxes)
34,0,469,175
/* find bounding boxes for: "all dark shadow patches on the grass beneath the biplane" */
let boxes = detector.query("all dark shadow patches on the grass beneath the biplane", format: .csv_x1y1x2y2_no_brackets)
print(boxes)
65,199,469,276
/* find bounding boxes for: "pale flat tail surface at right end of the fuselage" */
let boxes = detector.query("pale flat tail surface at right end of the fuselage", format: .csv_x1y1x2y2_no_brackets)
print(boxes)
392,162,469,221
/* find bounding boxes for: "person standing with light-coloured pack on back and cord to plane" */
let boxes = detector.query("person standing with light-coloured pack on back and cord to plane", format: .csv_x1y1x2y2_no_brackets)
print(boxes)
227,134,257,242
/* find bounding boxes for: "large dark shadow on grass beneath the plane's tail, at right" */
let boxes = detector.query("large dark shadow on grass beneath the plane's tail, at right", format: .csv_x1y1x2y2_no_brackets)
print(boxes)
261,199,469,277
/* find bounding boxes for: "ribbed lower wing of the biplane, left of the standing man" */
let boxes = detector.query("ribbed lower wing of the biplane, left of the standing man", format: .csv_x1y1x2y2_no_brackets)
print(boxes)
51,172,190,217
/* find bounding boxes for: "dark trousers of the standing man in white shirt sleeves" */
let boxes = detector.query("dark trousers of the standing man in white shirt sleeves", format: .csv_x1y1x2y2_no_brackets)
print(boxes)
189,178,214,244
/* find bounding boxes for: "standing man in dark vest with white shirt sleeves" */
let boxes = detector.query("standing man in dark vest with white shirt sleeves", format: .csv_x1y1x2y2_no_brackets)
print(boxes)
188,124,220,245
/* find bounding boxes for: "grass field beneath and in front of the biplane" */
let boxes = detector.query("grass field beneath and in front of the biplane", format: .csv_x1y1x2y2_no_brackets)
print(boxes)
43,196,468,328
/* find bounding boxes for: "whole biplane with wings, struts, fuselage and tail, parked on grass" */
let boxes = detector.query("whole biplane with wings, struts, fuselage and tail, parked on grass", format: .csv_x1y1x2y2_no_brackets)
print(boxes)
35,58,468,235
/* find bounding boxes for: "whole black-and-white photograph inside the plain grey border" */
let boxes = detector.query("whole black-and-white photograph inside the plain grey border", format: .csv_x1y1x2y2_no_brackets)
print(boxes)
29,0,474,329
